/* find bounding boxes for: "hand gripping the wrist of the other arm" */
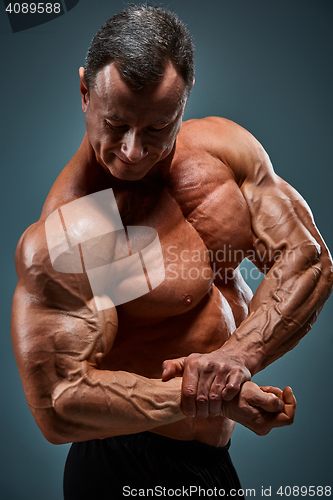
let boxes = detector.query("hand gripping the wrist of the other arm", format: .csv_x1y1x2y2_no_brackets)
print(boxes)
162,351,251,418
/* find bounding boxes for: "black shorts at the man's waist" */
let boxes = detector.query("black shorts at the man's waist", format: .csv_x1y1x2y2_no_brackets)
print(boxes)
64,432,243,500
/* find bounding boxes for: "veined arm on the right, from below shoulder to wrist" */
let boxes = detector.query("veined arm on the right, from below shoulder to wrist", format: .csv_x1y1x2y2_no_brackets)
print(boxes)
218,168,333,374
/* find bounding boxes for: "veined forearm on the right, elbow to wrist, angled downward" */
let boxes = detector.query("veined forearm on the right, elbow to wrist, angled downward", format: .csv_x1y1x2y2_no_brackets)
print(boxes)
221,241,332,375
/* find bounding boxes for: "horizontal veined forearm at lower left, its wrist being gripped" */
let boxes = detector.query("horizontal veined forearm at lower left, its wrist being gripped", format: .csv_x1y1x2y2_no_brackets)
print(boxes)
28,365,185,444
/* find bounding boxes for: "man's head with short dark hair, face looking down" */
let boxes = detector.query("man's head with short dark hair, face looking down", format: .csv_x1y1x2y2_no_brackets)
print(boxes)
80,5,194,180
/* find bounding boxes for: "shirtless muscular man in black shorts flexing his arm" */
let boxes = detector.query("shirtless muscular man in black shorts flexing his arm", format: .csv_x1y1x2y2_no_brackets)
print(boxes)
12,6,333,499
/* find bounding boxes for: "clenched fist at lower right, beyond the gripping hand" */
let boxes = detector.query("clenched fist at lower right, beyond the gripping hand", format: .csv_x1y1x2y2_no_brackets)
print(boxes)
222,382,296,436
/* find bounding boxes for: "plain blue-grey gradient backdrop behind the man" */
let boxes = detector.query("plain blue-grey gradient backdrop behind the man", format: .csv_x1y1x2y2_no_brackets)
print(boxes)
0,0,333,500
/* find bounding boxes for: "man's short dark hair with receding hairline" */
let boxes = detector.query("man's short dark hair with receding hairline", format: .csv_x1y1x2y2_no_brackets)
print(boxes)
85,4,194,94
